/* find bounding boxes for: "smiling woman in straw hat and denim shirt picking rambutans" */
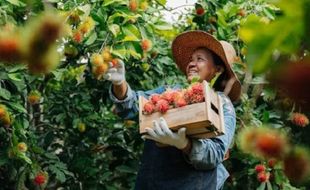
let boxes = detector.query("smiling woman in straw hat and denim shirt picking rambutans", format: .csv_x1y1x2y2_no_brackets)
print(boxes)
107,31,241,190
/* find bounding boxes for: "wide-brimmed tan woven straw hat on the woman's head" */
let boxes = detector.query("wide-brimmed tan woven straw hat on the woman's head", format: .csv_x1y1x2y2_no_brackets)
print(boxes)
172,30,241,102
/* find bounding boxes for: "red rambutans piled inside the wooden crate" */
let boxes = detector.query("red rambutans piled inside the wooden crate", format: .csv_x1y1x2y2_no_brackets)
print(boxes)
143,82,204,114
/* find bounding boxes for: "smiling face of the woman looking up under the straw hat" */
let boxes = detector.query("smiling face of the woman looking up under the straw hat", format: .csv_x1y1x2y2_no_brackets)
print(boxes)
186,48,221,82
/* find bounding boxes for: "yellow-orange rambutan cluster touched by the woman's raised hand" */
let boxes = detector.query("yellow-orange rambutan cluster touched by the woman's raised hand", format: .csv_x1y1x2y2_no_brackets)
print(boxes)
90,47,118,80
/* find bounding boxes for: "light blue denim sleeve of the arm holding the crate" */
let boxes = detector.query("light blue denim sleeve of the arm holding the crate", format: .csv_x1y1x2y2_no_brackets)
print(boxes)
186,93,236,170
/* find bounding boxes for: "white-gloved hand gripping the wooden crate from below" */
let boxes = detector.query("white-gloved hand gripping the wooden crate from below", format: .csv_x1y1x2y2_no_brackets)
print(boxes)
142,117,189,149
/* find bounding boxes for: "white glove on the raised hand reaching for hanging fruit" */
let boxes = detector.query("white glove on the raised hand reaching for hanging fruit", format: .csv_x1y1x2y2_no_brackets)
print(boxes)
104,59,125,85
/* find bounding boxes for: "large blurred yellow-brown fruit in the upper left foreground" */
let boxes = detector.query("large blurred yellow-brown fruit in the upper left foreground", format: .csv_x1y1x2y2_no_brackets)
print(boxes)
0,11,65,74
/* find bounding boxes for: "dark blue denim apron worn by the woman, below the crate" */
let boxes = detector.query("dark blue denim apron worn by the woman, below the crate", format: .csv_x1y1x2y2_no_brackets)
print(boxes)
135,140,217,190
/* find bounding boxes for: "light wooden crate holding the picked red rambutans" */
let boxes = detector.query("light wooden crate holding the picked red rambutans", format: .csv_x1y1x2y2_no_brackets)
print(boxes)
139,81,225,138
